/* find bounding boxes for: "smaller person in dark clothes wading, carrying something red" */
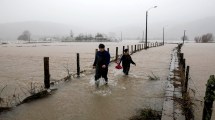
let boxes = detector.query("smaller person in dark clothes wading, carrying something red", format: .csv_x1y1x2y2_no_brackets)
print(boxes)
119,49,136,75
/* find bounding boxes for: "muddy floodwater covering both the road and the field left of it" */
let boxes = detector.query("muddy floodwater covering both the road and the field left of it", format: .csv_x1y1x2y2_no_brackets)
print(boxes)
0,43,176,120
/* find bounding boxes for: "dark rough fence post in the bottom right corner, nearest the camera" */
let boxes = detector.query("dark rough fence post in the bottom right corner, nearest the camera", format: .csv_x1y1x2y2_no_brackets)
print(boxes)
202,75,215,120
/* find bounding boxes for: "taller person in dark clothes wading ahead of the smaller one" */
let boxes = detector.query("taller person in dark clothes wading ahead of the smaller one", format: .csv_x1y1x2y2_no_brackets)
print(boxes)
93,44,110,84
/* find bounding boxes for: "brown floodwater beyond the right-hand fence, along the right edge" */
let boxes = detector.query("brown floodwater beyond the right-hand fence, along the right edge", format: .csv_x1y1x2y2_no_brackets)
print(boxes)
182,43,215,120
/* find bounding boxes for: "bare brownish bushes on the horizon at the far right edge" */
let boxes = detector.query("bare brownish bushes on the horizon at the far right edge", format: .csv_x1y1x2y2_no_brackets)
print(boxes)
194,33,214,43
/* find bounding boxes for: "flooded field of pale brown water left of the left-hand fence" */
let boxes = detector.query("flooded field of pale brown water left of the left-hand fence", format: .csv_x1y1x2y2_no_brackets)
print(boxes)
0,42,134,94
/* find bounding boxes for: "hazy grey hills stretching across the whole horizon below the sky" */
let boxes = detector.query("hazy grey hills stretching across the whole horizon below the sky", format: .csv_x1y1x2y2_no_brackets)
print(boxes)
0,16,215,40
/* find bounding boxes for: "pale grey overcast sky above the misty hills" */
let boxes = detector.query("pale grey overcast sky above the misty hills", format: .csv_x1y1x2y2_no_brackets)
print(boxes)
0,0,215,39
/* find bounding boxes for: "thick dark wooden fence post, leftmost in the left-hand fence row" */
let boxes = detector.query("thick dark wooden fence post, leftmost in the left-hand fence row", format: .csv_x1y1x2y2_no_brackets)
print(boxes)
44,57,50,89
